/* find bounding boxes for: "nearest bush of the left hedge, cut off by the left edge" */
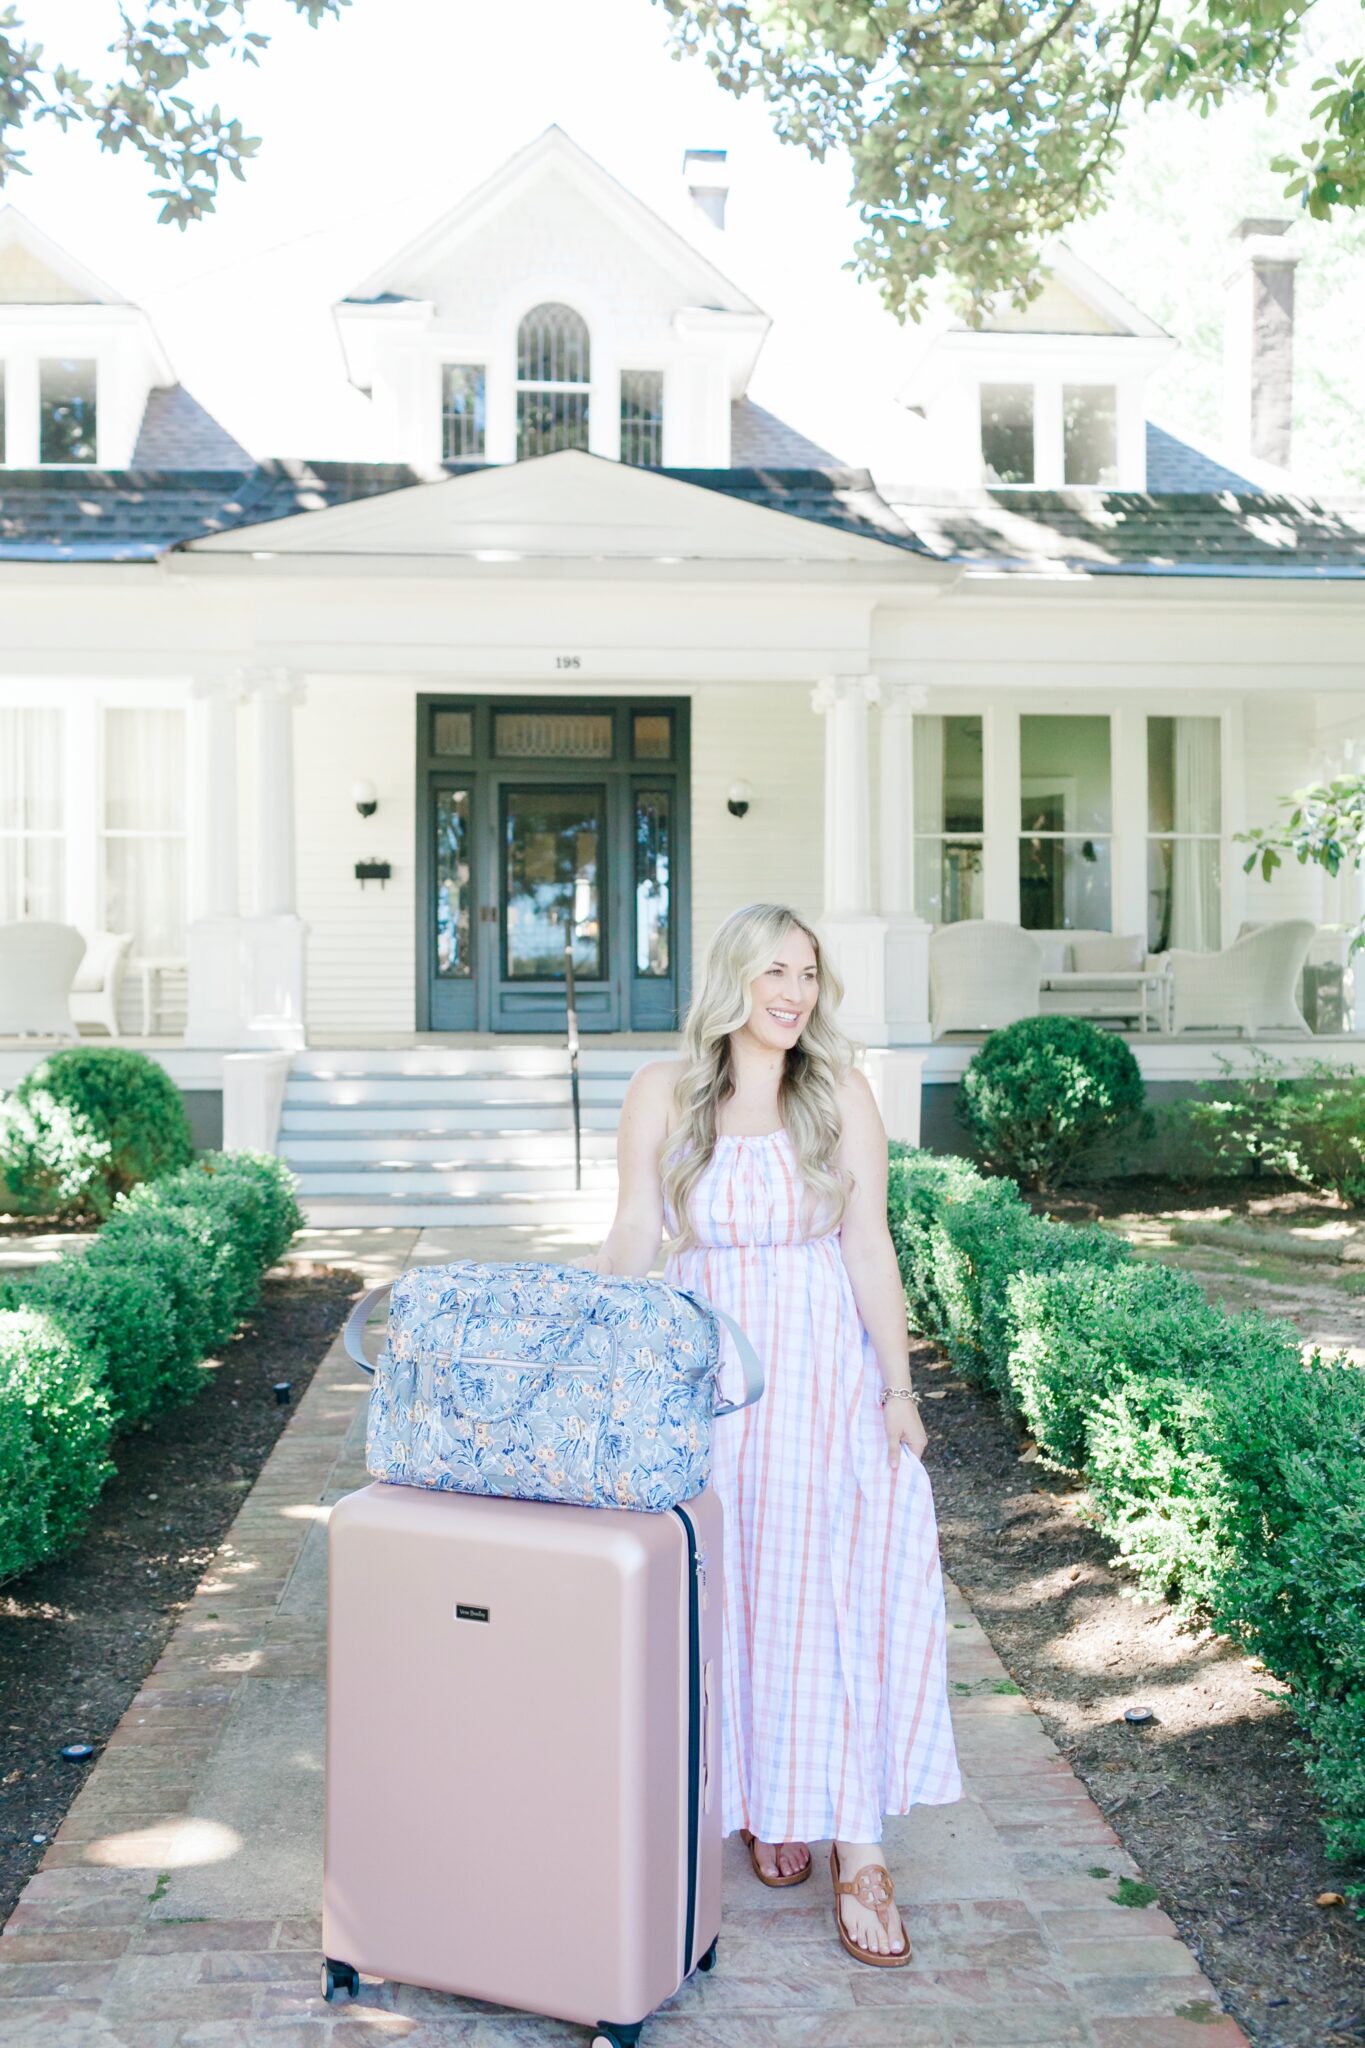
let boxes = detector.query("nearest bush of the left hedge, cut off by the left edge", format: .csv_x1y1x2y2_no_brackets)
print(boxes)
0,1309,113,1579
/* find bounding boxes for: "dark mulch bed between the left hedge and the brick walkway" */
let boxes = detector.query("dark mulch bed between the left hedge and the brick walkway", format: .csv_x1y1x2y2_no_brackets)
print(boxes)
0,1262,362,1923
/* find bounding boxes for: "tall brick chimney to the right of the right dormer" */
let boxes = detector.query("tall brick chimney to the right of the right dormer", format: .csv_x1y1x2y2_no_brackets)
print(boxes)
1224,219,1300,469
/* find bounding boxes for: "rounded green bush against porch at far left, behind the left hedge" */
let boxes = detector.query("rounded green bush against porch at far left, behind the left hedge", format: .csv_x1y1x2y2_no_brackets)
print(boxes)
0,1047,194,1221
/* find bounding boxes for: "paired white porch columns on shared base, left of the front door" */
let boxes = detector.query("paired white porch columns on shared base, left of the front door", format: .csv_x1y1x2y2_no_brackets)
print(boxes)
186,670,305,1051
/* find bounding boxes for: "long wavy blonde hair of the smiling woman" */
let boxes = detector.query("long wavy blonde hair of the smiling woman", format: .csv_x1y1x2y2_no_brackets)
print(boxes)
661,903,853,1251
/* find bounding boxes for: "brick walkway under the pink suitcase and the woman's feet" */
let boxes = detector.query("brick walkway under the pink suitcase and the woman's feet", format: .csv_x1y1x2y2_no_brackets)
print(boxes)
0,1231,1246,2048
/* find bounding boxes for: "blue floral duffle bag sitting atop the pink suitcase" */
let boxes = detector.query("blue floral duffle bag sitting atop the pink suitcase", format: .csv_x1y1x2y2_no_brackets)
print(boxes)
346,1260,763,1511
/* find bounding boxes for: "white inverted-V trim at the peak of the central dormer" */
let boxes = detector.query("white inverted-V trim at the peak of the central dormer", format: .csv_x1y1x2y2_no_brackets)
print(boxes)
342,125,761,313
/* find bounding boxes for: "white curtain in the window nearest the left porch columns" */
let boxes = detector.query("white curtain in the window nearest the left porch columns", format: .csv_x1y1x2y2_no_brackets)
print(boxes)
104,709,184,958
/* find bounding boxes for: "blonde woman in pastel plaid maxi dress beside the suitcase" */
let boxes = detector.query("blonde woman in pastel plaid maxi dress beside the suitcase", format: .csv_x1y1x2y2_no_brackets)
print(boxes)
587,903,962,1968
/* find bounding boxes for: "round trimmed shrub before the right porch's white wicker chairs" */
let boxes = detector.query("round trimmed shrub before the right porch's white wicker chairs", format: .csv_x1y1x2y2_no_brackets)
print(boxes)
958,1018,1152,1188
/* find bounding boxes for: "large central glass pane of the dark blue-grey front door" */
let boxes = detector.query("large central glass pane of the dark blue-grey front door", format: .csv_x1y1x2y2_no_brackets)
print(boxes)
503,784,606,981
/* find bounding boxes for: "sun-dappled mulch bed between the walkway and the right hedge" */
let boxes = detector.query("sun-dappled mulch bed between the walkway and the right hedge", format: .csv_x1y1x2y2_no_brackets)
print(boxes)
913,1310,1365,2048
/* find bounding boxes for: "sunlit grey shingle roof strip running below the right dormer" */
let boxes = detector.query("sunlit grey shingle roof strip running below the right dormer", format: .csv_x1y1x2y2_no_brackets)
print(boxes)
882,483,1365,580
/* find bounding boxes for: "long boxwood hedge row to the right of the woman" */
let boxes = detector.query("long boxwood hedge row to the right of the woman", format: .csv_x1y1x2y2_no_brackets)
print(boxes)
888,1145,1365,1913
